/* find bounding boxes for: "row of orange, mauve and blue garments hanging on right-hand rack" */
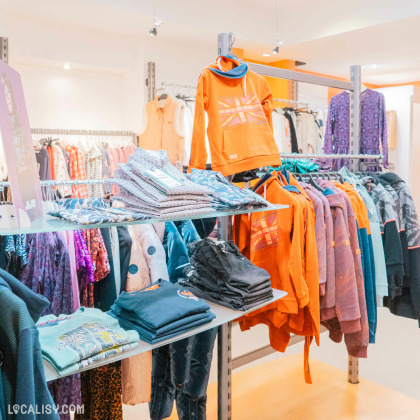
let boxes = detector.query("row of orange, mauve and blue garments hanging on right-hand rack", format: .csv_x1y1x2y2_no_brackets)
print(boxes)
234,166,420,382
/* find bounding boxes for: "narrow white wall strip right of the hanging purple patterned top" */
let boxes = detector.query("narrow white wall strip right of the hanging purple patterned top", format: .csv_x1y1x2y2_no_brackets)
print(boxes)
377,86,414,185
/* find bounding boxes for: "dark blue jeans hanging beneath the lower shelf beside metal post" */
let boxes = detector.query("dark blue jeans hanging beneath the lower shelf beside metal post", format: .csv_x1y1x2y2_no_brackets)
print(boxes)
149,328,217,420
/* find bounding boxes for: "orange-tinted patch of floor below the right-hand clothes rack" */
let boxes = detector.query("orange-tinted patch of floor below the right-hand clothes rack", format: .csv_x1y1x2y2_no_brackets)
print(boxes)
170,355,420,420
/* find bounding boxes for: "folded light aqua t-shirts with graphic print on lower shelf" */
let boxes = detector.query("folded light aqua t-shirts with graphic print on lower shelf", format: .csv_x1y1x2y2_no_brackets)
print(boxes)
36,307,139,375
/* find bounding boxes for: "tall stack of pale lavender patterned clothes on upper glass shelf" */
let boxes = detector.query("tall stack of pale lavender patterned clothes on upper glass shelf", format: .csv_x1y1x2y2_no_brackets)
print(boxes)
112,148,214,218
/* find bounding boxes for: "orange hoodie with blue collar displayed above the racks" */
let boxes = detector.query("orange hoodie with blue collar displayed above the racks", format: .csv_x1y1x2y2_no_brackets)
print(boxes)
189,57,281,176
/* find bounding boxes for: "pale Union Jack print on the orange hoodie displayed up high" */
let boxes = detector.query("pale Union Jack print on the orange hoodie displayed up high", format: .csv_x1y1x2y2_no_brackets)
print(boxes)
217,94,266,127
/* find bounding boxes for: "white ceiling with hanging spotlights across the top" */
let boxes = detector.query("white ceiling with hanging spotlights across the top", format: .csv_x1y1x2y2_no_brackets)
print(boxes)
0,0,420,84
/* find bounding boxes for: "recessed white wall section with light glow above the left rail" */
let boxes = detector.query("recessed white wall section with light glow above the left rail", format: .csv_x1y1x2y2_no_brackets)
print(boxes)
13,64,123,130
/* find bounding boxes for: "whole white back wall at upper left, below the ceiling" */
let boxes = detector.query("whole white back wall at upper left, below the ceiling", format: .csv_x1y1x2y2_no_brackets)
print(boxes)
0,12,213,131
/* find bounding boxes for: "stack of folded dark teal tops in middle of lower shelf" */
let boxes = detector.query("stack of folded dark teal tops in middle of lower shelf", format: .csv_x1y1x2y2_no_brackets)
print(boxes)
108,280,215,344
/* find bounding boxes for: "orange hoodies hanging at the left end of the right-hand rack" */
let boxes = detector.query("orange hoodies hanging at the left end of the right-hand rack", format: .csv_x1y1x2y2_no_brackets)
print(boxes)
235,173,320,383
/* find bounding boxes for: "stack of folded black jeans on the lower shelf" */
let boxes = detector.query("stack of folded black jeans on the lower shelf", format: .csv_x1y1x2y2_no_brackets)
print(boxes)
179,238,273,311
